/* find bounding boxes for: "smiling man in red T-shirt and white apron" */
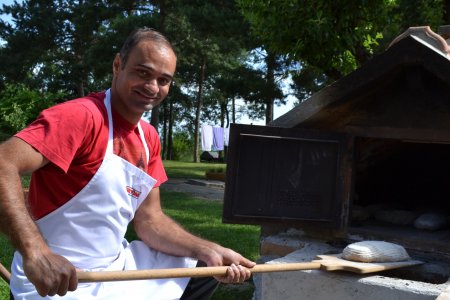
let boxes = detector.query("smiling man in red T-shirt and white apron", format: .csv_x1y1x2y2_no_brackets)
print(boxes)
0,29,254,300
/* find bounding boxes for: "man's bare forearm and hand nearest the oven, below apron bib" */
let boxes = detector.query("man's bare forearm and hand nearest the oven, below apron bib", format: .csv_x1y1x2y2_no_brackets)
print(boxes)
134,188,255,283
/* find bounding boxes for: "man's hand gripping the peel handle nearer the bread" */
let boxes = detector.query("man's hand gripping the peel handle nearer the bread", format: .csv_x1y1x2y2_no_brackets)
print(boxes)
198,244,255,283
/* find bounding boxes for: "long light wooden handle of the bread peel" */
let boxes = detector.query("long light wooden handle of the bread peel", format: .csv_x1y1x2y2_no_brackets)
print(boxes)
77,262,320,282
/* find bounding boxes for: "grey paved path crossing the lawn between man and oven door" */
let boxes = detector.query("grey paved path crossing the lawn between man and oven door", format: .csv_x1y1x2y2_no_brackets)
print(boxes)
161,178,225,201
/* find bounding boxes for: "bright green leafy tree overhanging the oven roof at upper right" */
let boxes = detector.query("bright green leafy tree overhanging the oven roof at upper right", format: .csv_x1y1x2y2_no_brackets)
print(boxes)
237,0,450,100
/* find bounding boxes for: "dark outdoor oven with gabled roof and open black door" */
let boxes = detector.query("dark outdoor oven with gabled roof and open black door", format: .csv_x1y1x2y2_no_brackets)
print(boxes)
223,27,450,298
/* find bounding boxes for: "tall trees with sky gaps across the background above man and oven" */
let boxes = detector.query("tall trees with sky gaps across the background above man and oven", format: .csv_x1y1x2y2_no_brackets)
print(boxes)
0,0,450,155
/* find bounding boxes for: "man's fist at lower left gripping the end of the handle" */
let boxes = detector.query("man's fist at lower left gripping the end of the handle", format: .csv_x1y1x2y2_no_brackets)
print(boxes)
23,251,78,297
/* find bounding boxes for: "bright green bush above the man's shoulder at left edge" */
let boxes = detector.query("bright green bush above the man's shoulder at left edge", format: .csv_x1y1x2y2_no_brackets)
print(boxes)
0,84,63,136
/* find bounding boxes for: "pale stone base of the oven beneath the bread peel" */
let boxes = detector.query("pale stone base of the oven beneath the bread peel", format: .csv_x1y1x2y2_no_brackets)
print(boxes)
254,235,450,300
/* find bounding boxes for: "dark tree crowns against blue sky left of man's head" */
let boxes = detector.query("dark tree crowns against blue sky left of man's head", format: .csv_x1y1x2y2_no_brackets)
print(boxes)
0,0,134,96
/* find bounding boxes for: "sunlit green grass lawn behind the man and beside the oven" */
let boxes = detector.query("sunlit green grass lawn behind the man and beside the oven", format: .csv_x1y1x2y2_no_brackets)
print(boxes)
0,161,260,300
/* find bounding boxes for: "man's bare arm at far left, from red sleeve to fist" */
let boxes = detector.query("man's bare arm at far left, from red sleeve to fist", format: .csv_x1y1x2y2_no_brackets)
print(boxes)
0,137,78,296
